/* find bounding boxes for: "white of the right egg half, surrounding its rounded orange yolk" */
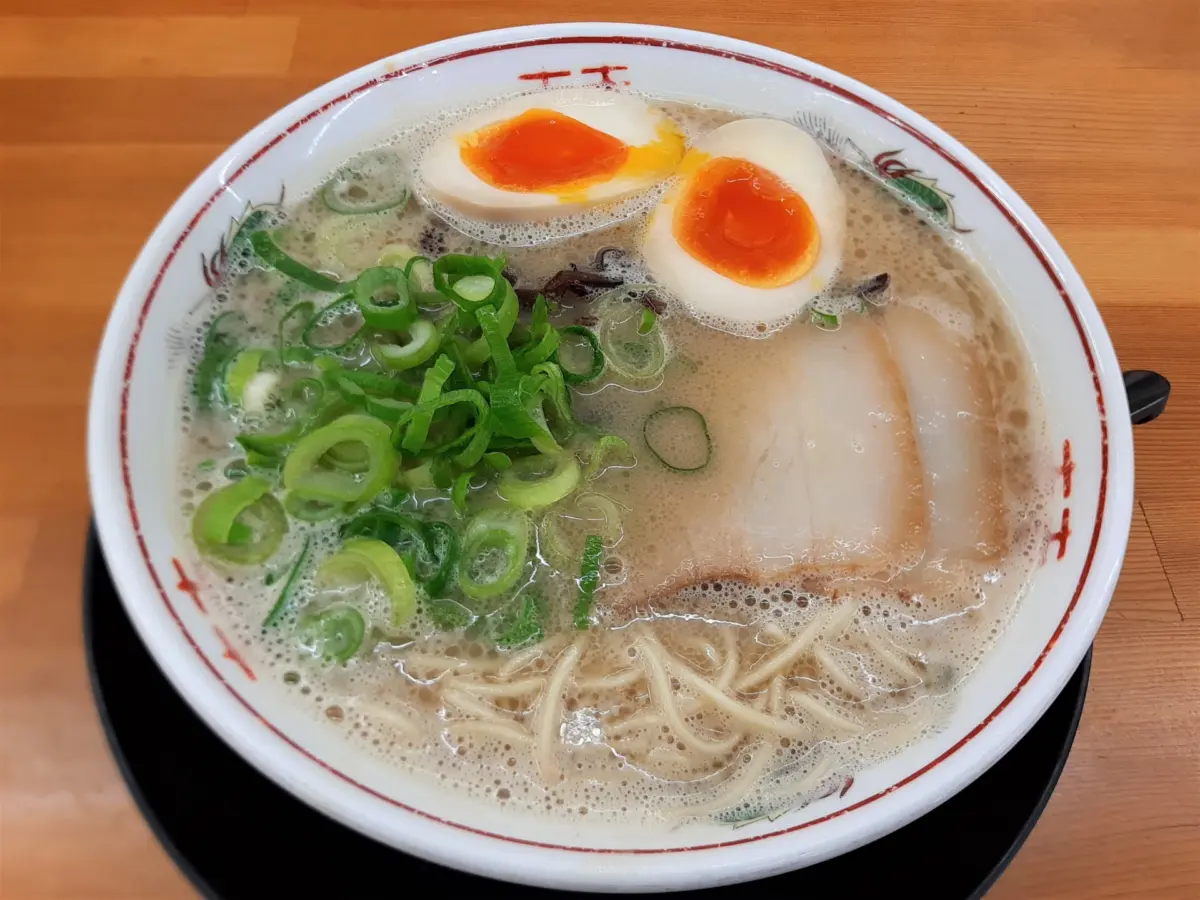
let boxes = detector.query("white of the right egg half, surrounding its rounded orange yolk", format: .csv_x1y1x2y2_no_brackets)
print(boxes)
642,119,846,325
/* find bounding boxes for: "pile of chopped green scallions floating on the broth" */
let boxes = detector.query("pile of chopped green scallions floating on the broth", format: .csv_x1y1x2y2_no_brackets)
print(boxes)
192,240,676,662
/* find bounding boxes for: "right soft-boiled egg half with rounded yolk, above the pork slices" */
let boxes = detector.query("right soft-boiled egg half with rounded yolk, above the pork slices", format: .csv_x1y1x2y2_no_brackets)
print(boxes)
643,119,846,325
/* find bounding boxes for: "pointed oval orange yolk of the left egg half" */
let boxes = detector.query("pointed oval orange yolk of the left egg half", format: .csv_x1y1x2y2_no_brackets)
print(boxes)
460,109,630,193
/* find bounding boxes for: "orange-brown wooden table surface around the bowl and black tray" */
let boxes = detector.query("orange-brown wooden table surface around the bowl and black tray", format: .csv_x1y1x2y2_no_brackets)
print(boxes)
0,0,1200,900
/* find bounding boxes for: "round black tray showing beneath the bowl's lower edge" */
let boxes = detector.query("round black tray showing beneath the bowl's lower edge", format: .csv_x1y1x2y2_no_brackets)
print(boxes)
84,532,1092,900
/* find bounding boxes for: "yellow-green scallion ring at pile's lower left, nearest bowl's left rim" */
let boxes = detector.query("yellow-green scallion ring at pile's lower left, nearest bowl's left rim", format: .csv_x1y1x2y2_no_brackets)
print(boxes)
192,475,288,565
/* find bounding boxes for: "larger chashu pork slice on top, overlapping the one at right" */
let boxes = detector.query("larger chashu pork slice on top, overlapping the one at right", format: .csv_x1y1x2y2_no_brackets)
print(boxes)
613,314,926,602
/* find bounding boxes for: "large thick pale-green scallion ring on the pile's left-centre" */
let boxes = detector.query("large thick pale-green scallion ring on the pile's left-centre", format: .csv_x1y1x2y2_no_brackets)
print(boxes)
283,414,400,504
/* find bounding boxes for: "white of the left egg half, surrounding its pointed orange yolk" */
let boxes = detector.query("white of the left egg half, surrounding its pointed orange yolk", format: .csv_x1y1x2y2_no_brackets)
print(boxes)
418,89,666,222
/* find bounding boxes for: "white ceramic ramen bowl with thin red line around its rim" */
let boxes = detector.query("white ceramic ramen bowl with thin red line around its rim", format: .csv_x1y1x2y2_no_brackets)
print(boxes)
88,24,1133,890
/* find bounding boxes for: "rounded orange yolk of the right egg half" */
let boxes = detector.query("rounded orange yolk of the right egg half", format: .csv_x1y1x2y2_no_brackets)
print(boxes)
672,156,821,288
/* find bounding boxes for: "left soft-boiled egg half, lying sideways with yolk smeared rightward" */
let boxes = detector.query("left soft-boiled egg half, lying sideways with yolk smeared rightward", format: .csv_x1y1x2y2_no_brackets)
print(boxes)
420,89,684,221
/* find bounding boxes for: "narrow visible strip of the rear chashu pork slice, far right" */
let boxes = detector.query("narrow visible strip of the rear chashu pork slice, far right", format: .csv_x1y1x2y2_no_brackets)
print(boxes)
882,305,1008,564
